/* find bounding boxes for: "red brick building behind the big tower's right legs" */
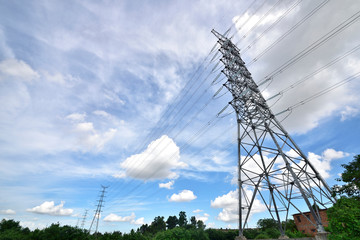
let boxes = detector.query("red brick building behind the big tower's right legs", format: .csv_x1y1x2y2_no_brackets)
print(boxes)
293,209,329,236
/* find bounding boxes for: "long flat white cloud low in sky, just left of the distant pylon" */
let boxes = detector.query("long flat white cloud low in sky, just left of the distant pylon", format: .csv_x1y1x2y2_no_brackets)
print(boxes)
26,201,74,216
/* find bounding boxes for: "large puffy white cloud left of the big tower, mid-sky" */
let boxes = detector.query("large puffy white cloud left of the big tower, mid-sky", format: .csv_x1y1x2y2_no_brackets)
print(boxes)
121,135,187,179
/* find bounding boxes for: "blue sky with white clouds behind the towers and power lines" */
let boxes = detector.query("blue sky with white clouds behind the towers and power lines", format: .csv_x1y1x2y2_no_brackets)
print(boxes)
0,0,360,232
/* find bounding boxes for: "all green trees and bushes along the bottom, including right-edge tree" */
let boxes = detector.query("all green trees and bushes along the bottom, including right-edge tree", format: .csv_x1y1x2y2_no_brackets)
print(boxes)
0,155,360,240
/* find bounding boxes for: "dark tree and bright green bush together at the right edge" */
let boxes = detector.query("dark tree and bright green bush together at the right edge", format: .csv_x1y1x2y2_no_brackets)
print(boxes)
327,155,360,240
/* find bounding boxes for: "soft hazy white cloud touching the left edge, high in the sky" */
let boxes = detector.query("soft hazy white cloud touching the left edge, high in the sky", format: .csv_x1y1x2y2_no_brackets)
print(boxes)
0,59,40,81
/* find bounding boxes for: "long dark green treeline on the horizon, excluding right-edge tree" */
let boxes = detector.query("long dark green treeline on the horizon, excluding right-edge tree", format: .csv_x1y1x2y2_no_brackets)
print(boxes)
0,211,305,240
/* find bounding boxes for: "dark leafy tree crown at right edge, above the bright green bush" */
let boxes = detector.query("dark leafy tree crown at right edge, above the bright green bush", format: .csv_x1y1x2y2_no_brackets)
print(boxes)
332,155,360,198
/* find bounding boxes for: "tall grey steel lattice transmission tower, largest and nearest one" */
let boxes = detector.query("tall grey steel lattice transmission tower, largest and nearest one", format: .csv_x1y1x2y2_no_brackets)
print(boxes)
212,30,335,239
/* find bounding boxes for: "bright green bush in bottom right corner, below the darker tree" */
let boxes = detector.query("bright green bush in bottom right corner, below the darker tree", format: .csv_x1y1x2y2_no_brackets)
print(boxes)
327,197,360,240
